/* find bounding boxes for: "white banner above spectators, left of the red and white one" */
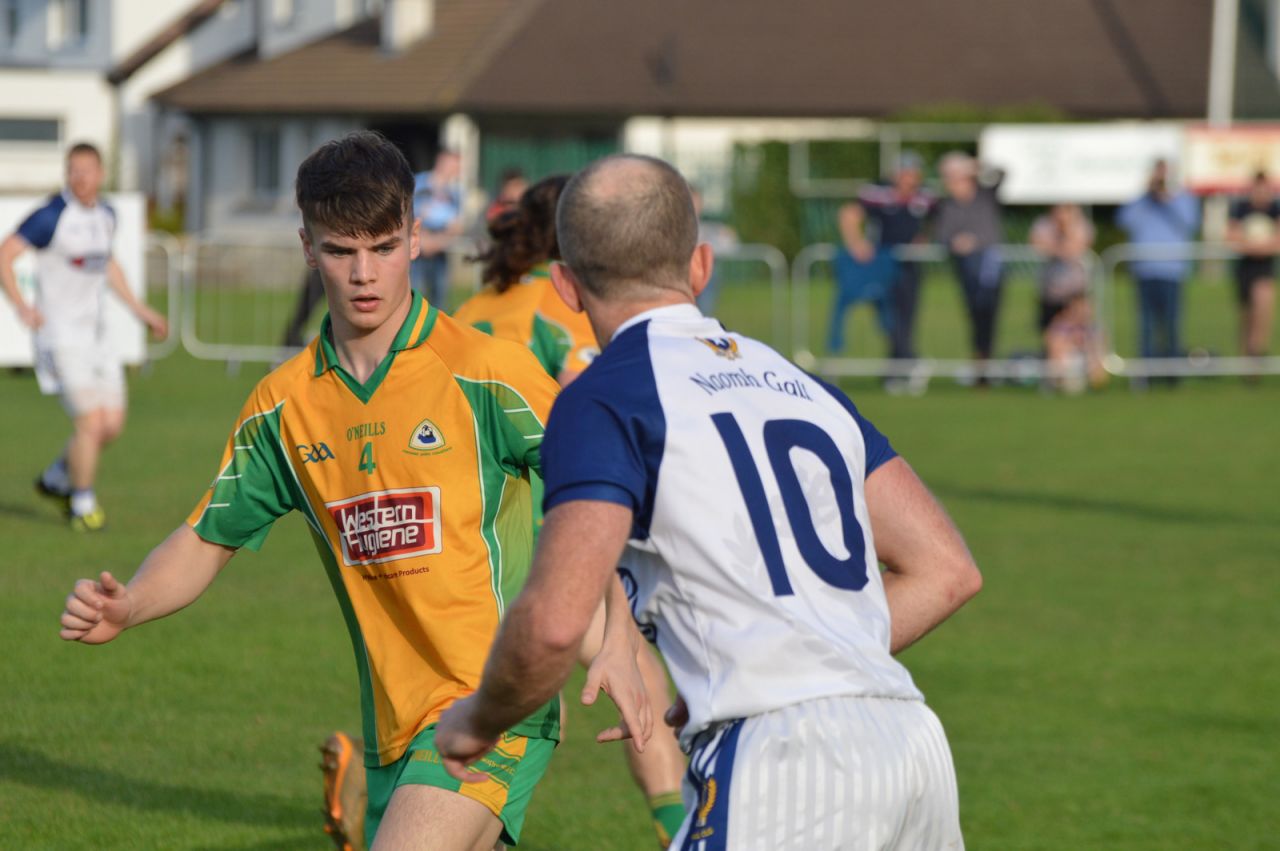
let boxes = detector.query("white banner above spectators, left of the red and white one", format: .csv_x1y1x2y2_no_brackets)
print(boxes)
978,124,1184,203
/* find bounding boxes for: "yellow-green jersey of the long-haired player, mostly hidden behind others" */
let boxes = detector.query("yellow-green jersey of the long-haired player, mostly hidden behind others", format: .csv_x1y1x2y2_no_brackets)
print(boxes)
453,264,600,378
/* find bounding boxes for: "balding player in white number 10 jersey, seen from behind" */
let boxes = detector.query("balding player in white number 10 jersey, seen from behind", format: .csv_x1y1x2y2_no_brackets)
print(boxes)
436,156,982,851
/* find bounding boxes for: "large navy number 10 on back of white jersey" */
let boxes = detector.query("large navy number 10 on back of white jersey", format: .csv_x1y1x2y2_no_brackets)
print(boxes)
712,413,867,596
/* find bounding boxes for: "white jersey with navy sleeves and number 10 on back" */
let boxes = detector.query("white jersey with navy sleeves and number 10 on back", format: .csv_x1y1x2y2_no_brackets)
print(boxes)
543,305,923,745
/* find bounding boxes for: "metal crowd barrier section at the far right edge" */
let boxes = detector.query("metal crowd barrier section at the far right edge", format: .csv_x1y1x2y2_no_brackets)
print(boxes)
1102,243,1280,378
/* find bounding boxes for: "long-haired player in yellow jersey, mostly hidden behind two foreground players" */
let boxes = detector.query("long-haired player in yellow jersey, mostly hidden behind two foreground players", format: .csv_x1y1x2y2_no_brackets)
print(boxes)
453,175,686,848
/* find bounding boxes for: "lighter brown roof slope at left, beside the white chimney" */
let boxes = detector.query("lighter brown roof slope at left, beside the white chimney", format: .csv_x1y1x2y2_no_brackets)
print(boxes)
156,0,543,114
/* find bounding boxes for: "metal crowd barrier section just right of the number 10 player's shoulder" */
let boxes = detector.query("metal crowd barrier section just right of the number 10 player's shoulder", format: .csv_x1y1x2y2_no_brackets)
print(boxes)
791,243,1110,380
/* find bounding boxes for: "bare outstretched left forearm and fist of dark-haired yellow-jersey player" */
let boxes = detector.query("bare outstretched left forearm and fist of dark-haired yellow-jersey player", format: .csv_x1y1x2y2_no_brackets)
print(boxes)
59,523,236,644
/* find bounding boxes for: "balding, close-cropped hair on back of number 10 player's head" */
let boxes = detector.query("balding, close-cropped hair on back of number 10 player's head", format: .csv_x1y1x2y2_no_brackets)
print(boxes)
556,154,698,297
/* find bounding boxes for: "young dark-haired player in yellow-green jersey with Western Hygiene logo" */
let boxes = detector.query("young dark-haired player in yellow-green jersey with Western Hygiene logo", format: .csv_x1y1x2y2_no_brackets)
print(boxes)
61,133,649,851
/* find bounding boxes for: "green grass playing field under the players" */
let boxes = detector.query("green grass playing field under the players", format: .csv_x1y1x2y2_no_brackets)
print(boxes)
0,284,1280,851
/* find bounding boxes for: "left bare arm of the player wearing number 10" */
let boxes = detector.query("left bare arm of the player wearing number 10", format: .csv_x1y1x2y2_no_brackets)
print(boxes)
435,500,649,781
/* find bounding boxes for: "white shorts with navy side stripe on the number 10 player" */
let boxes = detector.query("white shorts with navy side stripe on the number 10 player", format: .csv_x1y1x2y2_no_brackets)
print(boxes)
671,697,964,851
